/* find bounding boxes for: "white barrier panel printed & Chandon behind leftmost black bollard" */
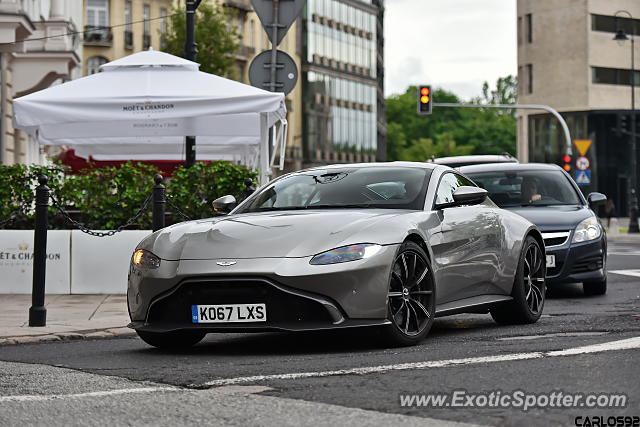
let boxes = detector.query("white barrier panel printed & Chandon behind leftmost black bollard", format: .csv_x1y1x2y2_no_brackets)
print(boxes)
0,230,71,294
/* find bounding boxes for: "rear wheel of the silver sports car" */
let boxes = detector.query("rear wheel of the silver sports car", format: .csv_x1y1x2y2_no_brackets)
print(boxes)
490,236,546,324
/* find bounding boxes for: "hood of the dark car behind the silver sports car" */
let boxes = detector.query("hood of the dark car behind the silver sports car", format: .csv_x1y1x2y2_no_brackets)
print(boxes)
508,205,594,232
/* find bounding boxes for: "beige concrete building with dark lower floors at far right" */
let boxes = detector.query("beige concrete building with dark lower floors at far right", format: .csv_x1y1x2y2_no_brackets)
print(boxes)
517,0,640,215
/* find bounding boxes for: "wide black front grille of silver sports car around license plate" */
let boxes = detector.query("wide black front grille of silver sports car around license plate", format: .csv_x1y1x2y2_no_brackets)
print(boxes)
147,280,332,327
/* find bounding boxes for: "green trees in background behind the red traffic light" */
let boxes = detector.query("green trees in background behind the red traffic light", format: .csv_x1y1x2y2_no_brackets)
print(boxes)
386,76,517,161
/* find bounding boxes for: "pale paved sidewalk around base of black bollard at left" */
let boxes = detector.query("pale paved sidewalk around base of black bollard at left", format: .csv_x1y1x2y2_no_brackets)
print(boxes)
0,294,135,346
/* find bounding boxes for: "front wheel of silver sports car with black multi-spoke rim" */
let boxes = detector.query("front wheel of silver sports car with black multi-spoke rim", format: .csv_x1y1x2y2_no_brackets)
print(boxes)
384,241,436,346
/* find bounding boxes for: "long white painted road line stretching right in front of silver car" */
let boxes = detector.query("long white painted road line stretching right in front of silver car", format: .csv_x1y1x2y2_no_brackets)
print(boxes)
199,337,640,387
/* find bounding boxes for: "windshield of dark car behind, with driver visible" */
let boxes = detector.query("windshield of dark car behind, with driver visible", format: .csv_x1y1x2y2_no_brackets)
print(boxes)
465,170,581,208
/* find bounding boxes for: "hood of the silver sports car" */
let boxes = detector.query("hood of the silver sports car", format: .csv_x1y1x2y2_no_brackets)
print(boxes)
145,209,402,260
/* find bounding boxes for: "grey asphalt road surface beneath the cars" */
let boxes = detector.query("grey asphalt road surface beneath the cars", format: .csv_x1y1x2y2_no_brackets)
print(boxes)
0,243,640,426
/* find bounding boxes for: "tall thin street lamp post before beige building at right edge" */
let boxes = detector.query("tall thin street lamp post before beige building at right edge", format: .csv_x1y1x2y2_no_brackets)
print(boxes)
613,10,640,233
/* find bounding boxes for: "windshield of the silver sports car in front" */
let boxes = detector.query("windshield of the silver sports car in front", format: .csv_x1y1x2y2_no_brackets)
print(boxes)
235,166,431,213
